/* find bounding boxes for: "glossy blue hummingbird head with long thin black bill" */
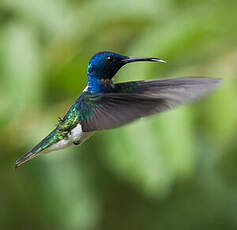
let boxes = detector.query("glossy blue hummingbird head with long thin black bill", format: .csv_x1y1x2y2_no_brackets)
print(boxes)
87,52,165,79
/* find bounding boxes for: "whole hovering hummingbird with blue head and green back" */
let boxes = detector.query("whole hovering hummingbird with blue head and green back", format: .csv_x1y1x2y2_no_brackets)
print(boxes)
15,51,221,167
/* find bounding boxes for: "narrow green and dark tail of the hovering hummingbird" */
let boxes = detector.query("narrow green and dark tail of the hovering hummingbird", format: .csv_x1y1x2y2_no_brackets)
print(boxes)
15,128,66,168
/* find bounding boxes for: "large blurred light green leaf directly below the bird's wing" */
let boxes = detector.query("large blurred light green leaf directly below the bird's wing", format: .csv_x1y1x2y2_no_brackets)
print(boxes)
103,109,195,198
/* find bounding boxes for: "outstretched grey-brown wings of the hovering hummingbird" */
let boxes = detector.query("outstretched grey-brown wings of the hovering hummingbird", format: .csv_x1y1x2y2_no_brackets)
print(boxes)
79,77,220,132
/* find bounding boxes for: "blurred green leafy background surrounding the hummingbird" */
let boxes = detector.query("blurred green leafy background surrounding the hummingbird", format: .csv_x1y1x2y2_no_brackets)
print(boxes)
0,0,237,230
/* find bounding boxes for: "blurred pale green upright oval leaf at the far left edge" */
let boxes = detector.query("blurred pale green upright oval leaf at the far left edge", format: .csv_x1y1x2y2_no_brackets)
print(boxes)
3,23,42,118
